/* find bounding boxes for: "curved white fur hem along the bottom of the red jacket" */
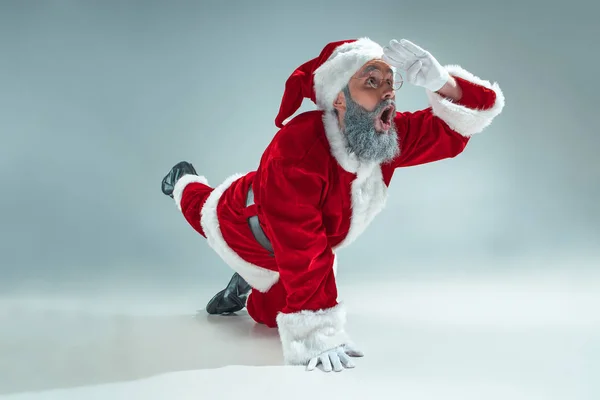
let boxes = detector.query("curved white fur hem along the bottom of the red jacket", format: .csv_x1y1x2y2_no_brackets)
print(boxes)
200,174,279,292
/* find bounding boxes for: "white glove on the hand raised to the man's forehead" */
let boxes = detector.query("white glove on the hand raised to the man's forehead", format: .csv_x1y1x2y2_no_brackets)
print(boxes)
383,39,450,92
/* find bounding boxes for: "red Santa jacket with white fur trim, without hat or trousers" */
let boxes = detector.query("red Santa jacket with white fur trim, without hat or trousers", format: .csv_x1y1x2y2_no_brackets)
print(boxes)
176,66,504,366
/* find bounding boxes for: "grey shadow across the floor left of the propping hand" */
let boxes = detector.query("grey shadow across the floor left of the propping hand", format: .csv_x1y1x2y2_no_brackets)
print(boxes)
0,310,282,394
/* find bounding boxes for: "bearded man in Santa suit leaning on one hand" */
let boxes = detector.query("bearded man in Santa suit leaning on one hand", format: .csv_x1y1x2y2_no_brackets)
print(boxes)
162,38,504,371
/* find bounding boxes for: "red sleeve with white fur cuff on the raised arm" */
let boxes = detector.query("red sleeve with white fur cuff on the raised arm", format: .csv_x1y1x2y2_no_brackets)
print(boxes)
393,72,503,168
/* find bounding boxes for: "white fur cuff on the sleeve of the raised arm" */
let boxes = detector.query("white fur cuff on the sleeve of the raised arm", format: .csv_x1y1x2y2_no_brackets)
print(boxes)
426,65,504,137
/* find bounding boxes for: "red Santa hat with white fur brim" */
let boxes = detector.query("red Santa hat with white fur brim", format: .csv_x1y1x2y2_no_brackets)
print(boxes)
275,38,383,128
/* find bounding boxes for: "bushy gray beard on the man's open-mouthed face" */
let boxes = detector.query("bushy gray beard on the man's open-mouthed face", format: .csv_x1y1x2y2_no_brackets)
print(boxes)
343,86,400,163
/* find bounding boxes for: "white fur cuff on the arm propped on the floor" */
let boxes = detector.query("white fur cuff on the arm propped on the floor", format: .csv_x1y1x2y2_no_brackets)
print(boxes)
277,303,350,365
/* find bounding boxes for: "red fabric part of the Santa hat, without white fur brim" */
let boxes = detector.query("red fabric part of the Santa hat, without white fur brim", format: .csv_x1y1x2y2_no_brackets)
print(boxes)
275,39,355,128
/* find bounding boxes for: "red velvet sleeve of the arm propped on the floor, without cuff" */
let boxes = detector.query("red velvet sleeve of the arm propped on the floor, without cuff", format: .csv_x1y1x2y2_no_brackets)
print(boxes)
261,159,337,314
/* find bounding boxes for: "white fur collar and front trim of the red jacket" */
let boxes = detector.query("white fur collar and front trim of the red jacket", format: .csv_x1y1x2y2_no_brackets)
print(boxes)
323,112,387,250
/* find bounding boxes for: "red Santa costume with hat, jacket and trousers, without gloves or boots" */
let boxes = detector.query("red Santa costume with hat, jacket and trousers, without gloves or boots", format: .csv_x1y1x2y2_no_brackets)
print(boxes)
162,38,504,365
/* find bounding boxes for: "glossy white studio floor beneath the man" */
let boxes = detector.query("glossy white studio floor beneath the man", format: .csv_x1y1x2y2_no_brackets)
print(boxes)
0,273,600,400
